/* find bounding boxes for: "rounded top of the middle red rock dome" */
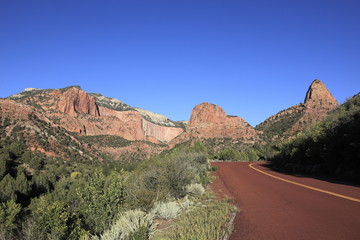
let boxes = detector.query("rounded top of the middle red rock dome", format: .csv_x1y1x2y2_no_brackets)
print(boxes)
187,102,227,128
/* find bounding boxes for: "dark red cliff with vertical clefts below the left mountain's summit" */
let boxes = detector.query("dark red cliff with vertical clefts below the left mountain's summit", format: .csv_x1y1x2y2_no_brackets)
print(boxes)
58,88,100,117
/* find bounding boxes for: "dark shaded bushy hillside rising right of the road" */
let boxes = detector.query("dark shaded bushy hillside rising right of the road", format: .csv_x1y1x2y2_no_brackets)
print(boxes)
272,94,360,183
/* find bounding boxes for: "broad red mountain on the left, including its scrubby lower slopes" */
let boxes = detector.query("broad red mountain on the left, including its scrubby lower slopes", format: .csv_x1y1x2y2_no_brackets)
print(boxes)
4,86,185,159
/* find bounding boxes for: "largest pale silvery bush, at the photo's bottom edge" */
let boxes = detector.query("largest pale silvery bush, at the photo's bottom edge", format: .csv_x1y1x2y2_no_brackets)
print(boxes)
95,209,156,240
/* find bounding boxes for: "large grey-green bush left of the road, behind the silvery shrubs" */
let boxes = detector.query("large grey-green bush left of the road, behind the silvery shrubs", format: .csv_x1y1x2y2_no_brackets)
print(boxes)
126,152,208,210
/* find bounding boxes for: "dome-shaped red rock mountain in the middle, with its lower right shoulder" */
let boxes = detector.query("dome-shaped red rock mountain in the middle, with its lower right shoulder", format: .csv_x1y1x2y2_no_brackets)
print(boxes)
173,103,257,144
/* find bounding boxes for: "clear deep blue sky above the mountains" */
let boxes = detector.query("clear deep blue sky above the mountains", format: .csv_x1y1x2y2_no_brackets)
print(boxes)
0,0,360,126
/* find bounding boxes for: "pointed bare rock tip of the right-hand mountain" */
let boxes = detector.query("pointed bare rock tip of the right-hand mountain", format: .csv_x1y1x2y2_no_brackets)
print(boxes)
304,79,338,106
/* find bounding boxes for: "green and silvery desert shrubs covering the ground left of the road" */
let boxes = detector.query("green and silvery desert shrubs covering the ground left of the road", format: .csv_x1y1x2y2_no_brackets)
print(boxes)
0,122,232,240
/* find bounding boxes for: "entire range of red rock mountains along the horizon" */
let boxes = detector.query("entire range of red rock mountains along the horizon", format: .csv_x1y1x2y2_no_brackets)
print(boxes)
0,80,346,159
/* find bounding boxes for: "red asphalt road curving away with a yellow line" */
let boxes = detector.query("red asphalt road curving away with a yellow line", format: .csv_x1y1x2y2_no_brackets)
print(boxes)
212,162,360,240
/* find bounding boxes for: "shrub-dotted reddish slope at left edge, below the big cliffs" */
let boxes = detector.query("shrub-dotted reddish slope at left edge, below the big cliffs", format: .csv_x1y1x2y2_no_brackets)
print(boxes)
0,99,102,160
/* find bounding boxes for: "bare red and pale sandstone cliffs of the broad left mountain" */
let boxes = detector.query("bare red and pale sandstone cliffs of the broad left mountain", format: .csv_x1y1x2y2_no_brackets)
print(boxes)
10,86,184,143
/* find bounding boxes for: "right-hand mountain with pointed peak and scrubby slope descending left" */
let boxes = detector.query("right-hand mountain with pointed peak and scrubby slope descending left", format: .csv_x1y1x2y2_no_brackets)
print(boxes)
255,79,338,142
